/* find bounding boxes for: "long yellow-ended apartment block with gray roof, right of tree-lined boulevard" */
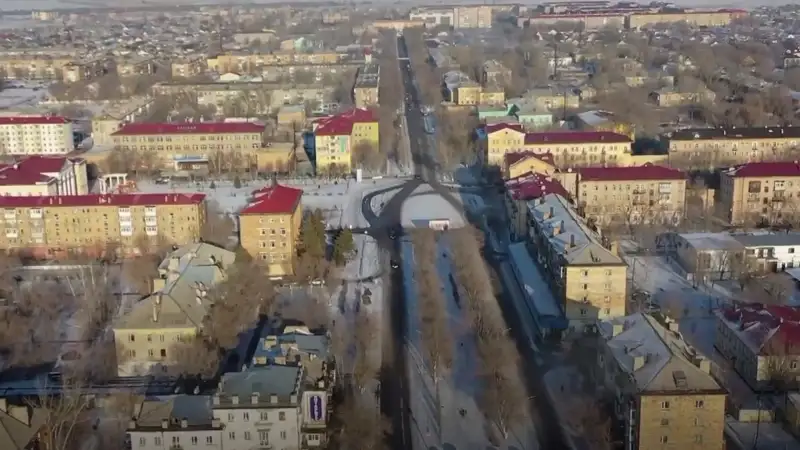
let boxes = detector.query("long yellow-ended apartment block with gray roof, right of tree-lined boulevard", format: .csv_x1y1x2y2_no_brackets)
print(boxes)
528,194,628,331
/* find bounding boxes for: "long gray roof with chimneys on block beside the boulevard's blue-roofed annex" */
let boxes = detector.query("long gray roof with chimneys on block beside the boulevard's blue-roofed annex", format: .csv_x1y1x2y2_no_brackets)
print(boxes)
528,194,625,265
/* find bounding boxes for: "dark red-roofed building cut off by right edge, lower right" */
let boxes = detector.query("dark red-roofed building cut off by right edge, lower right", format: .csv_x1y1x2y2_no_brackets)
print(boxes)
714,303,800,391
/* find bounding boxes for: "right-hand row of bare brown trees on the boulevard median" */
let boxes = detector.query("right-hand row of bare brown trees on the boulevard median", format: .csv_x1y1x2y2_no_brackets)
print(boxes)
447,227,529,438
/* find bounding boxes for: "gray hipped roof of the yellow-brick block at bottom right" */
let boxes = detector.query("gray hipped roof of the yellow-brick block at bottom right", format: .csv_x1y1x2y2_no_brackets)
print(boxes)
598,313,721,393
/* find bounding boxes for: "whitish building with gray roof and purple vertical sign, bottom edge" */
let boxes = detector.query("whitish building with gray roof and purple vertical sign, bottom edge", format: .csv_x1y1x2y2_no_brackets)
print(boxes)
212,365,328,450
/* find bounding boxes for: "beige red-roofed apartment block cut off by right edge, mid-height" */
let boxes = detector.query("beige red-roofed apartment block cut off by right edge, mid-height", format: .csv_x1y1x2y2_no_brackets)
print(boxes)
715,162,800,224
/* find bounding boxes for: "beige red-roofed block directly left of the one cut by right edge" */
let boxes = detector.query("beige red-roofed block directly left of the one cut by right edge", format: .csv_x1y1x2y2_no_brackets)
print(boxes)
576,164,686,225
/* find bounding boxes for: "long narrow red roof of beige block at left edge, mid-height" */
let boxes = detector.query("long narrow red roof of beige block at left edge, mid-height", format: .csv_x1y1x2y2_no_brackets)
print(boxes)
0,193,206,208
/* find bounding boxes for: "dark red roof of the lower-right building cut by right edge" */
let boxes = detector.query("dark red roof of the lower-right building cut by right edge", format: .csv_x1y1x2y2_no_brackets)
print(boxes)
721,303,800,355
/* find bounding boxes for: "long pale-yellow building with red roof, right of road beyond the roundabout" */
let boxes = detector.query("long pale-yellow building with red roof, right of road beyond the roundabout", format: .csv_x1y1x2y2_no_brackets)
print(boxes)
478,123,633,169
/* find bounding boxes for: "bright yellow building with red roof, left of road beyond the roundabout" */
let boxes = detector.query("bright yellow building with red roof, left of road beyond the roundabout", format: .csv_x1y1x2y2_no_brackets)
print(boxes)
314,108,379,172
